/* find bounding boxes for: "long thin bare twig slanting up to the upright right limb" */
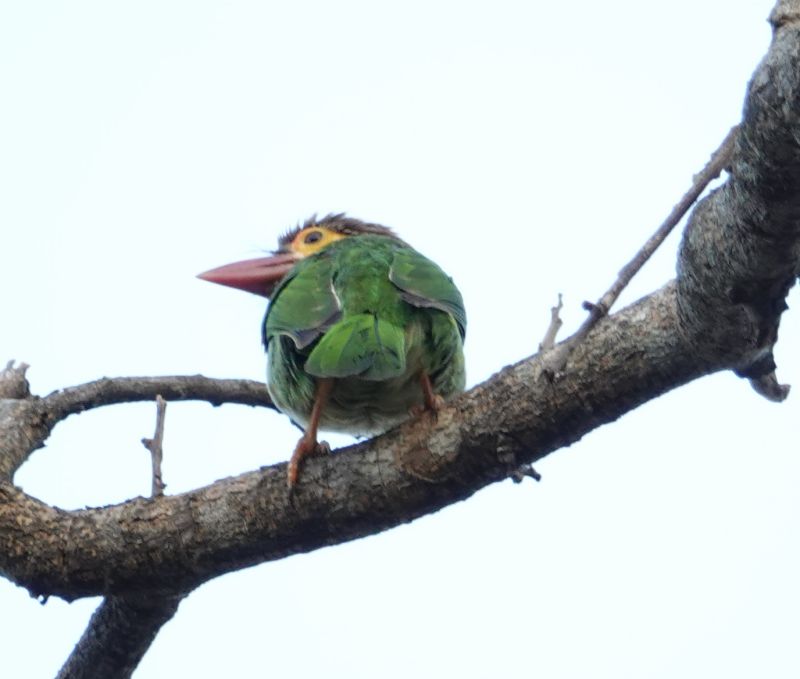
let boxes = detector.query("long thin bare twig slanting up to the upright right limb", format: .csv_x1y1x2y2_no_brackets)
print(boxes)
562,125,739,350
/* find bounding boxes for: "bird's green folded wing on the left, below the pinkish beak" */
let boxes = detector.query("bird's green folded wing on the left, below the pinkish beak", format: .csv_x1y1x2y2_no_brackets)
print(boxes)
263,257,341,349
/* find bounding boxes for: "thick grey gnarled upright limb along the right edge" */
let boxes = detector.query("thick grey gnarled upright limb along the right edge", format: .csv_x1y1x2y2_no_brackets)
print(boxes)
678,5,800,386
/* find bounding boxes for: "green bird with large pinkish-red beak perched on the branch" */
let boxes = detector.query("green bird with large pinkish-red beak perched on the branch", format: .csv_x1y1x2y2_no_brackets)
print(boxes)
199,214,467,488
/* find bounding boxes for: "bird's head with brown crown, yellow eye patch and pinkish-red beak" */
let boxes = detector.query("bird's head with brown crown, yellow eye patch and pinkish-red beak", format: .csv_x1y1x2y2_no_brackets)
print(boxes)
197,214,399,297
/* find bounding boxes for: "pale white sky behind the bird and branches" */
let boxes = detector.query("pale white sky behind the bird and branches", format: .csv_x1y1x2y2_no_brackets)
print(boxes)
0,0,800,679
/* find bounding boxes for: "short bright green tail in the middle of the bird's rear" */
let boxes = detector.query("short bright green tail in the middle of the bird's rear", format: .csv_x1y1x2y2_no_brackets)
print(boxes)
305,314,406,380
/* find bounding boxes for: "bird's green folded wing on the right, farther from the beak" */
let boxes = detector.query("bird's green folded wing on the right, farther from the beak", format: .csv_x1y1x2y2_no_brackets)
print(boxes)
389,248,467,339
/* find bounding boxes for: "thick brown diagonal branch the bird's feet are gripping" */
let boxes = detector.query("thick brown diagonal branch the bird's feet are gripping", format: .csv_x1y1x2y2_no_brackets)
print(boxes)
0,286,714,599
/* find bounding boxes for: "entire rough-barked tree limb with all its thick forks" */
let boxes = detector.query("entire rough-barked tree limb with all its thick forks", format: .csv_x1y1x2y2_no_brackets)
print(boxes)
0,0,800,677
